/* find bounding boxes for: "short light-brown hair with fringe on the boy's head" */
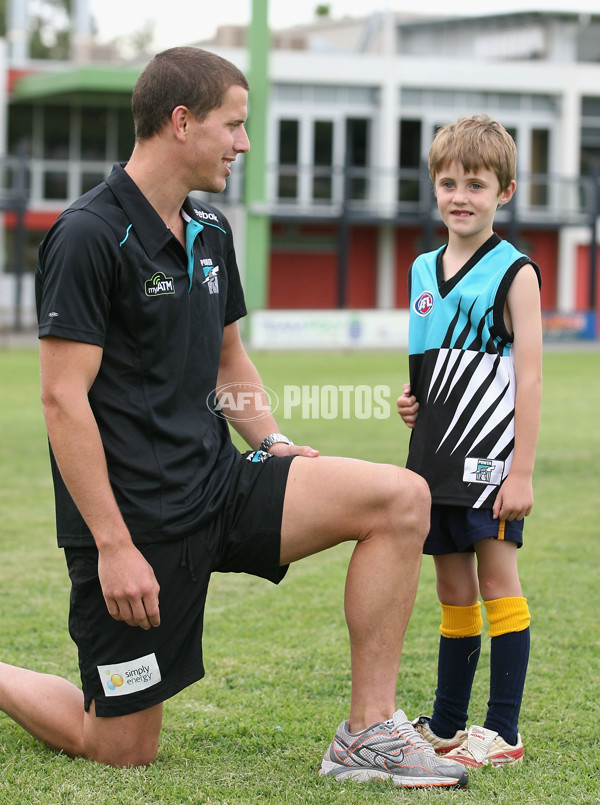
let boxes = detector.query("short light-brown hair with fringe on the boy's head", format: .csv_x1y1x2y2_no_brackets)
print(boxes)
429,115,517,192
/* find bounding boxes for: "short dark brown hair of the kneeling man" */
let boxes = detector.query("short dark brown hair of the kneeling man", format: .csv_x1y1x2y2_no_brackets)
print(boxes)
131,47,249,140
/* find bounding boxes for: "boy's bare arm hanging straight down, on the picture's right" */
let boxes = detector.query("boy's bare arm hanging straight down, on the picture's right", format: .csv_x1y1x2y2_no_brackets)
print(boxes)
493,265,542,520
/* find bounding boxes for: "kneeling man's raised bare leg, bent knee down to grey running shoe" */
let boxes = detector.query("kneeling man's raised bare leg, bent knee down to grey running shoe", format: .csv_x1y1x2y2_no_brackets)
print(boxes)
281,457,430,732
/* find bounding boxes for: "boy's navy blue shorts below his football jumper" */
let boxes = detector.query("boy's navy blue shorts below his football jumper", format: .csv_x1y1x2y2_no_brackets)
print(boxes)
423,503,524,556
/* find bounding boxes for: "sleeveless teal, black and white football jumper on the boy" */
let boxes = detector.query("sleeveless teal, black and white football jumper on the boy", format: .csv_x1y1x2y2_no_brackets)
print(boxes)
406,234,541,509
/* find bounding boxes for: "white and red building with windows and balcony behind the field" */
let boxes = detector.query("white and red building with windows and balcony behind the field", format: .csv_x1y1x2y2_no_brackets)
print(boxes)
0,4,600,346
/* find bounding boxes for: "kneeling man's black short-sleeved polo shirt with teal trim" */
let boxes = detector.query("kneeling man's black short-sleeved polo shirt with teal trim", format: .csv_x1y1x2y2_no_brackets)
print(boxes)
36,165,246,546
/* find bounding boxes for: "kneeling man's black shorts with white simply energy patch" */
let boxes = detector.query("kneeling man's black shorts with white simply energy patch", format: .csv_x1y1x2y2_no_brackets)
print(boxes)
65,451,293,716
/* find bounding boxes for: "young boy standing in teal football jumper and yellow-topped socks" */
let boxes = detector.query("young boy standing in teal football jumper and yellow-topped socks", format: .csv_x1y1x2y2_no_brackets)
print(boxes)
397,115,542,766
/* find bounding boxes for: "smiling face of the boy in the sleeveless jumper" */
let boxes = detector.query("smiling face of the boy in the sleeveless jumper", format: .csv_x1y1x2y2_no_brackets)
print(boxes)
434,161,516,243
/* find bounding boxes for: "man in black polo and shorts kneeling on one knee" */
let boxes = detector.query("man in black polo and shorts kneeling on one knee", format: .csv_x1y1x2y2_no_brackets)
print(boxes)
0,48,467,788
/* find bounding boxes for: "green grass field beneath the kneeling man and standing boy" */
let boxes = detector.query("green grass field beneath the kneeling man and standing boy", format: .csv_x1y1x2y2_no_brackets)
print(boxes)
0,349,600,805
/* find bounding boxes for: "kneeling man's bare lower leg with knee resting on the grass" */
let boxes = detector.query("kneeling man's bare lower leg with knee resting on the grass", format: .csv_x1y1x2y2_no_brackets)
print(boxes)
0,663,162,766
